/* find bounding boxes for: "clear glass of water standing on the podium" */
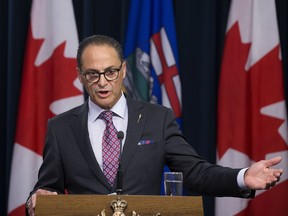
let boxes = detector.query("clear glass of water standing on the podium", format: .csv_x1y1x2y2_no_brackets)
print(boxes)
164,172,183,196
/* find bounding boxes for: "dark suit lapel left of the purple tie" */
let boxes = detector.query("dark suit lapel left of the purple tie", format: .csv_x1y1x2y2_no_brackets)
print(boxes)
70,101,111,189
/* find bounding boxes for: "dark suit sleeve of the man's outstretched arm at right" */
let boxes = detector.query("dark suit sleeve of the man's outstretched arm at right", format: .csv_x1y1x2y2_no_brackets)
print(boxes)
163,110,254,197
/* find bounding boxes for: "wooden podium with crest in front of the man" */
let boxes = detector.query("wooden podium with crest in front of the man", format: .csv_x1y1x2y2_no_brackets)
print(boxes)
35,195,204,216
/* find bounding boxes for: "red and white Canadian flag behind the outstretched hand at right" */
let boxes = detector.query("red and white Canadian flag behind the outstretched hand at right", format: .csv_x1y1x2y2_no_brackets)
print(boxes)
216,0,288,216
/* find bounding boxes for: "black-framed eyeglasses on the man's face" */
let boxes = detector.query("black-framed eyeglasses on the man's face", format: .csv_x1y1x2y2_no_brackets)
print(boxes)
80,62,123,83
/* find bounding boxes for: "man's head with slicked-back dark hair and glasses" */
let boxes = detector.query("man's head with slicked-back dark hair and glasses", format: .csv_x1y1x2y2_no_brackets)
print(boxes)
77,35,126,109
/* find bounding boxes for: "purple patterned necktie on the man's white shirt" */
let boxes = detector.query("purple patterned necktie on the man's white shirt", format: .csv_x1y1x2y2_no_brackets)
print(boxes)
99,111,120,186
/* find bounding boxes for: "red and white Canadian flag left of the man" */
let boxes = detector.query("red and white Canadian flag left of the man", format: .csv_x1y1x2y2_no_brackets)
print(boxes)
8,0,84,216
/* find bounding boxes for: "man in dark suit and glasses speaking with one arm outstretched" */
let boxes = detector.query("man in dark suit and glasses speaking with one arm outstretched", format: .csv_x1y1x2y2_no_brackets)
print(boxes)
27,35,283,215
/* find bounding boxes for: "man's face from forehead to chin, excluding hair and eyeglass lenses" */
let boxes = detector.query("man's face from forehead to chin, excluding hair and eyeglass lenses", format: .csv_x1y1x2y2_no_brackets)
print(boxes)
78,45,126,109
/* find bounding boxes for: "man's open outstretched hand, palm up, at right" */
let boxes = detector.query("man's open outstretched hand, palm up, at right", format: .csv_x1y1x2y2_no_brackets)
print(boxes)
244,156,283,190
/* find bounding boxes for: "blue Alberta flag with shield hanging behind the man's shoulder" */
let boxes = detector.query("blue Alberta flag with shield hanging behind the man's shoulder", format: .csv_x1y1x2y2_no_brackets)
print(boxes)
124,0,182,123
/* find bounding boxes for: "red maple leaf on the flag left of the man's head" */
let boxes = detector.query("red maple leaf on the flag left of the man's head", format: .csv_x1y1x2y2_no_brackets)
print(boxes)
16,27,82,155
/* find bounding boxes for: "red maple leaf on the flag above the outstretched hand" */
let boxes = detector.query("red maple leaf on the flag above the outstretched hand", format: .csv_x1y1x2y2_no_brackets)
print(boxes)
218,23,287,161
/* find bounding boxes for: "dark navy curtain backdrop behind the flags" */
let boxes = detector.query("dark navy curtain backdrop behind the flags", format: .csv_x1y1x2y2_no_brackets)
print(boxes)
0,0,288,215
